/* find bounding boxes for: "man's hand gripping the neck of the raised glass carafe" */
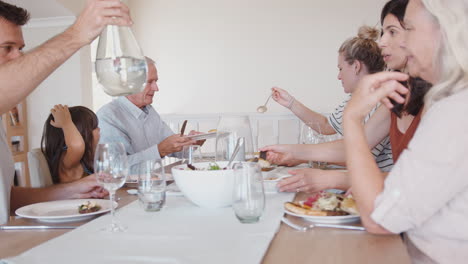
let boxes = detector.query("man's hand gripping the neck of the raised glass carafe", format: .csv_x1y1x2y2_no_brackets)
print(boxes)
70,0,133,45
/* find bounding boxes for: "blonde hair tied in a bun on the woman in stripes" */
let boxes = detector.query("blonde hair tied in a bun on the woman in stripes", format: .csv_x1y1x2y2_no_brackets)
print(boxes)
338,26,385,73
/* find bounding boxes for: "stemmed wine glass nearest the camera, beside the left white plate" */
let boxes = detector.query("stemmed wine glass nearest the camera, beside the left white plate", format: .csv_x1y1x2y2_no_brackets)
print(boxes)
94,143,128,232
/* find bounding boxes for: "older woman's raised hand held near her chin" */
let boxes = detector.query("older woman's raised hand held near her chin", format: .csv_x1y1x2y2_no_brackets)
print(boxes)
344,72,409,122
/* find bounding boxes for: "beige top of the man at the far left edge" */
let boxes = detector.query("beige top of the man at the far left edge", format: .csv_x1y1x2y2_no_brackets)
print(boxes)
0,121,15,225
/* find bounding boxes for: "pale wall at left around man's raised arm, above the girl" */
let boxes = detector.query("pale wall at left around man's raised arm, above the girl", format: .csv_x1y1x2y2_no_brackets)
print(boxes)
23,26,92,149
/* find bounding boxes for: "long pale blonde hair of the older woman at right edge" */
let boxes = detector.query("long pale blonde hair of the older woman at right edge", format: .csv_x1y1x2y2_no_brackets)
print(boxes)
422,0,468,107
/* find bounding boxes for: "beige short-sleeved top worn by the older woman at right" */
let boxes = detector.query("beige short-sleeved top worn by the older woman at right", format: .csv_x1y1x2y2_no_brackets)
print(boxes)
372,89,468,263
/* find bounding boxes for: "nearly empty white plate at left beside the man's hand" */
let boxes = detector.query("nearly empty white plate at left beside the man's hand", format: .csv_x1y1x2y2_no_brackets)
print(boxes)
15,199,118,223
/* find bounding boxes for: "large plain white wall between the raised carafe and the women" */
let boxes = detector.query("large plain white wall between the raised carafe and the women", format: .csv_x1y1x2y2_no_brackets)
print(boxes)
113,0,385,113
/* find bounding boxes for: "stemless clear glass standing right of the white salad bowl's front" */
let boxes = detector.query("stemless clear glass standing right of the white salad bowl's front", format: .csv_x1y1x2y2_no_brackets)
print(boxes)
232,162,265,223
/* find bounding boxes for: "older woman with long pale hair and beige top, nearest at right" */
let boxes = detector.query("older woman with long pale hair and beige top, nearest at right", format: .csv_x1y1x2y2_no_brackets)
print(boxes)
344,0,468,263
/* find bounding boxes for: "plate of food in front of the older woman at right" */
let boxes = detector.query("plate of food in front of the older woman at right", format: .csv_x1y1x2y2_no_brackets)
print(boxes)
284,191,360,224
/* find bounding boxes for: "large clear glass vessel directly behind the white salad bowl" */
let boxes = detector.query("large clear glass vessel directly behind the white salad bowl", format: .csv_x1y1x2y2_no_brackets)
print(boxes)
215,116,254,161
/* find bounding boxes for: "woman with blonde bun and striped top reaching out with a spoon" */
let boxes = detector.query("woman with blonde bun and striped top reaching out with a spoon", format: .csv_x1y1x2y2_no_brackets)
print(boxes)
266,26,393,170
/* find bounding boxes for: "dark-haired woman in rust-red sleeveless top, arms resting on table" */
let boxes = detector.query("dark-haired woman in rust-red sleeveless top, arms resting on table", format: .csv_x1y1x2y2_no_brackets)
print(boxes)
261,0,431,192
